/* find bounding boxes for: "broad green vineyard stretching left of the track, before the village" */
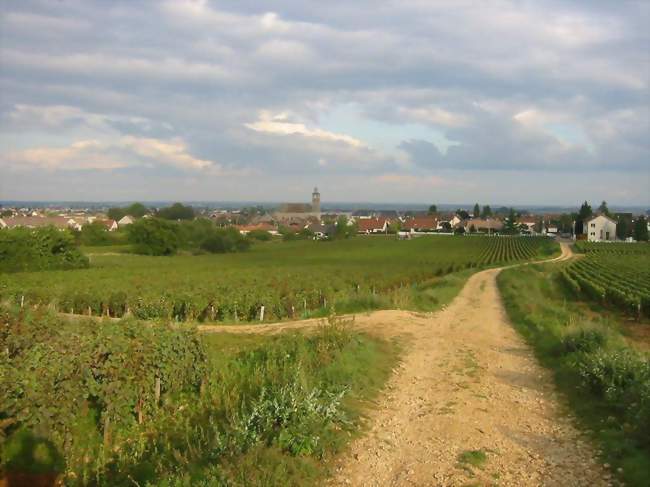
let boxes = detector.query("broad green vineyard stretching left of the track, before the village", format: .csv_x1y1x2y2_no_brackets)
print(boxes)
0,237,557,322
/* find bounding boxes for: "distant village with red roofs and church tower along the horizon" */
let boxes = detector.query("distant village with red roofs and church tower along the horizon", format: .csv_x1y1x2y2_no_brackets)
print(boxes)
0,188,650,242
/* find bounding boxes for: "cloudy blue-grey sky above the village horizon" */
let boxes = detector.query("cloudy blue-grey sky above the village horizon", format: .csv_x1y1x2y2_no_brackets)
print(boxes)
0,0,650,206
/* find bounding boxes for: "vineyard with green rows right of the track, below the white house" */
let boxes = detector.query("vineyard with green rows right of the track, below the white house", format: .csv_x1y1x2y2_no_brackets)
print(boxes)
562,242,650,317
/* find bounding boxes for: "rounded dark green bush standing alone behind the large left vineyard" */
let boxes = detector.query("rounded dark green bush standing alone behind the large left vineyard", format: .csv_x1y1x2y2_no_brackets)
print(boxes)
128,218,181,255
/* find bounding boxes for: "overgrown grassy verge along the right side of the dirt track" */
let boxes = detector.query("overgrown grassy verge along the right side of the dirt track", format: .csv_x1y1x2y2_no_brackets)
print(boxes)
497,265,650,486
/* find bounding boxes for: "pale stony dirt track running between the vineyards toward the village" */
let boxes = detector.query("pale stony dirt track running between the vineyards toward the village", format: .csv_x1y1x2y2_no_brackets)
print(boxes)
203,245,609,486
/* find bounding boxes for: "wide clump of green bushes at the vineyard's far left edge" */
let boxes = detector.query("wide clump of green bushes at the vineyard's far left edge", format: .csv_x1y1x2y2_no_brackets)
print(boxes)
0,227,88,272
